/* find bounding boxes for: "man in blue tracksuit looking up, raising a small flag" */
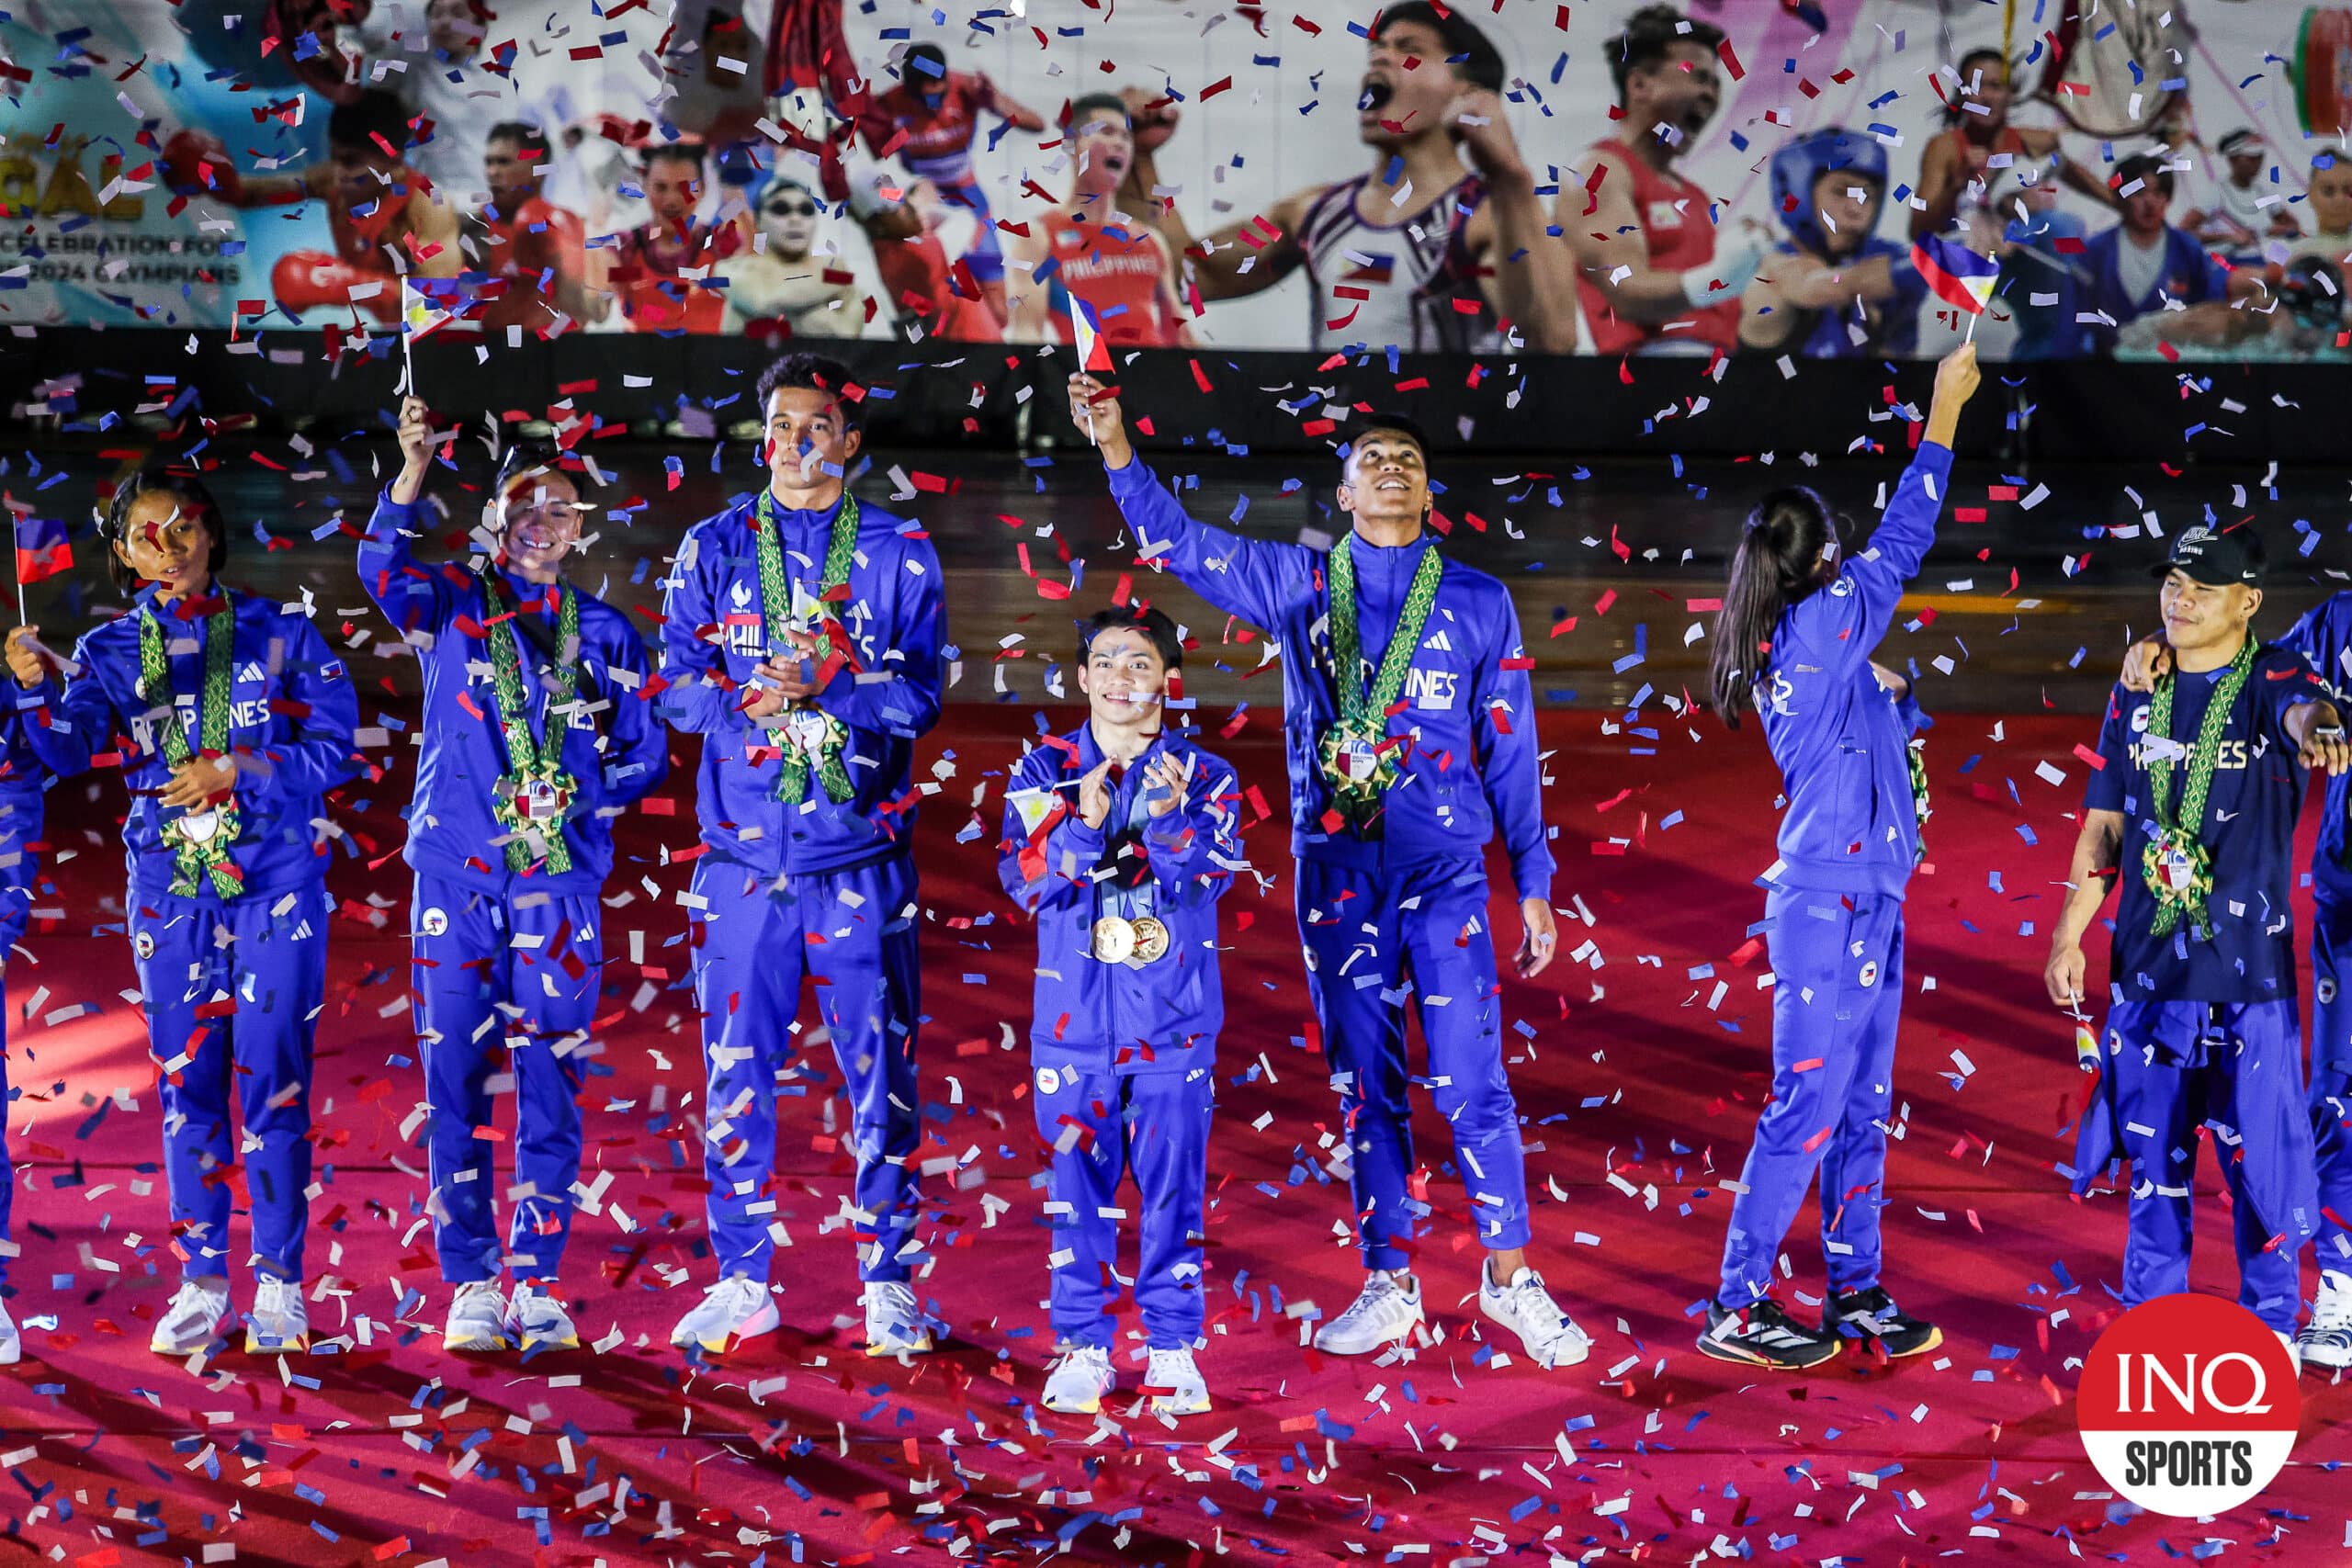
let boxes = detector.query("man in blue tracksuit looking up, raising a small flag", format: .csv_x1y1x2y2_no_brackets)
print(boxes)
1070,374,1590,1366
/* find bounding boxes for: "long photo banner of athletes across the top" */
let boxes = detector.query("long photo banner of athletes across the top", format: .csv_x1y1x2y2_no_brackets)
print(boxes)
0,0,2352,360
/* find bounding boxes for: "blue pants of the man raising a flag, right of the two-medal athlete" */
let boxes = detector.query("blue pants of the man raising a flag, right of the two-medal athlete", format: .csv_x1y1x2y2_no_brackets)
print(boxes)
1298,861,1529,1269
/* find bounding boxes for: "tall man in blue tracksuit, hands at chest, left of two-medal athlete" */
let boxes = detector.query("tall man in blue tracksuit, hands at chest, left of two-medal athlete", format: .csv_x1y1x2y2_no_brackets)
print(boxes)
654,355,945,1354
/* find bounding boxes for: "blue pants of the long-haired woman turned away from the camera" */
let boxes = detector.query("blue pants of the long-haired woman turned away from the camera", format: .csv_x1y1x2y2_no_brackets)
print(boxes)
1717,886,1903,1309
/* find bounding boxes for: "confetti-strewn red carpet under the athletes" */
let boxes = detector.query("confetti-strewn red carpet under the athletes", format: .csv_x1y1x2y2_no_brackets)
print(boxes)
0,707,2352,1568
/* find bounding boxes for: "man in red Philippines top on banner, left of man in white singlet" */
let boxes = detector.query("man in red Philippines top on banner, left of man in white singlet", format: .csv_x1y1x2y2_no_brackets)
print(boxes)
1007,92,1188,348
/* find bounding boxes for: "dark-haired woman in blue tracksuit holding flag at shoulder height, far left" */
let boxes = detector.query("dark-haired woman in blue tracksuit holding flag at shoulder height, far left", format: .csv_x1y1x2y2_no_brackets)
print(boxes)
9,472,362,1354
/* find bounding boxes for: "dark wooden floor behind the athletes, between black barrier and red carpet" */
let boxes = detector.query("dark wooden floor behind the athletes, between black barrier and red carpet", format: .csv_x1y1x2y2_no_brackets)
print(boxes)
18,433,2352,717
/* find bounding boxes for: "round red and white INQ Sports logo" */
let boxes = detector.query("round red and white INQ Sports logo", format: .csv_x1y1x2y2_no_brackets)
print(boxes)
2075,1295,2302,1518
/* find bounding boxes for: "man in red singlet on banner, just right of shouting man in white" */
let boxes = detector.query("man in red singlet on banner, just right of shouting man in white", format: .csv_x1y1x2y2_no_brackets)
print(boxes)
1553,5,1764,355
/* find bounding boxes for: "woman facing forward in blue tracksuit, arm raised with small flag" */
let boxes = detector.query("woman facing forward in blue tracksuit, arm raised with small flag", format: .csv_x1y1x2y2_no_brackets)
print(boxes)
360,398,668,1352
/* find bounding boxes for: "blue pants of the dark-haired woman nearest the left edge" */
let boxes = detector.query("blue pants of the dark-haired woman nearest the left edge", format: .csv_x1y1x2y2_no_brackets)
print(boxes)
130,884,334,1279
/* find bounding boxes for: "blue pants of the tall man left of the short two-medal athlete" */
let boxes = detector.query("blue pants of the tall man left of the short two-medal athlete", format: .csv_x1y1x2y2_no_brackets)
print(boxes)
692,856,922,1281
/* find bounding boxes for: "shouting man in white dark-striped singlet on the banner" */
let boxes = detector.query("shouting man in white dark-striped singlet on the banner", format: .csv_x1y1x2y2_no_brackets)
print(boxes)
1120,0,1576,353
